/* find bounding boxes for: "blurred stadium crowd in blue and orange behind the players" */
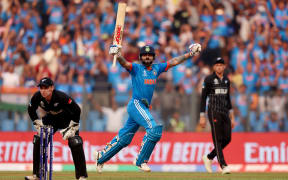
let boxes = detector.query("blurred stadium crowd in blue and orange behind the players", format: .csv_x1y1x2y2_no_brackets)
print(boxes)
0,0,288,132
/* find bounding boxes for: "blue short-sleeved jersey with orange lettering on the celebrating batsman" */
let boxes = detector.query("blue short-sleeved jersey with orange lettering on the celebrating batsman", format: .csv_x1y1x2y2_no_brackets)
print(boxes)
128,63,168,104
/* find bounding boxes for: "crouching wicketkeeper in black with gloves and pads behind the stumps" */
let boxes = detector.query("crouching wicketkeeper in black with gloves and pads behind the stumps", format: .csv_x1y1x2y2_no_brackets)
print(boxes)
25,77,88,180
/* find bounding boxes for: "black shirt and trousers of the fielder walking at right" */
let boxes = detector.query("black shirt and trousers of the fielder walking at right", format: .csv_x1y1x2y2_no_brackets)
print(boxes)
200,72,232,167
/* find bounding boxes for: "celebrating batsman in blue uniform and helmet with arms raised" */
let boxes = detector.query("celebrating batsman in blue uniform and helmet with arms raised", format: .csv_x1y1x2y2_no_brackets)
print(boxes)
94,43,201,172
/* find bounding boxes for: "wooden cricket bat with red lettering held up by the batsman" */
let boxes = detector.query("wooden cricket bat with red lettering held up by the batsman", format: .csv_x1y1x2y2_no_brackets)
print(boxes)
112,2,127,67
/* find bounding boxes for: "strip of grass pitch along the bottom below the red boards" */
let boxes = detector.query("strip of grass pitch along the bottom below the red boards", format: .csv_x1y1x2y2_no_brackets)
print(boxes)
0,171,288,180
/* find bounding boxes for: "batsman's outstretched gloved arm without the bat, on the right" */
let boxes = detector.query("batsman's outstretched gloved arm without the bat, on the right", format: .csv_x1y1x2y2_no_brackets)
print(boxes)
168,43,201,68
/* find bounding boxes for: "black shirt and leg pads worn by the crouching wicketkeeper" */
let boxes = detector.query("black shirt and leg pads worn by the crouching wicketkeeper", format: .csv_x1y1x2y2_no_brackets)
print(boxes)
28,90,87,179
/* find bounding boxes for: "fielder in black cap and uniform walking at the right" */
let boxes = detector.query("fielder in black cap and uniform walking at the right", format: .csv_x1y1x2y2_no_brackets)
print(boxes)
199,57,235,174
